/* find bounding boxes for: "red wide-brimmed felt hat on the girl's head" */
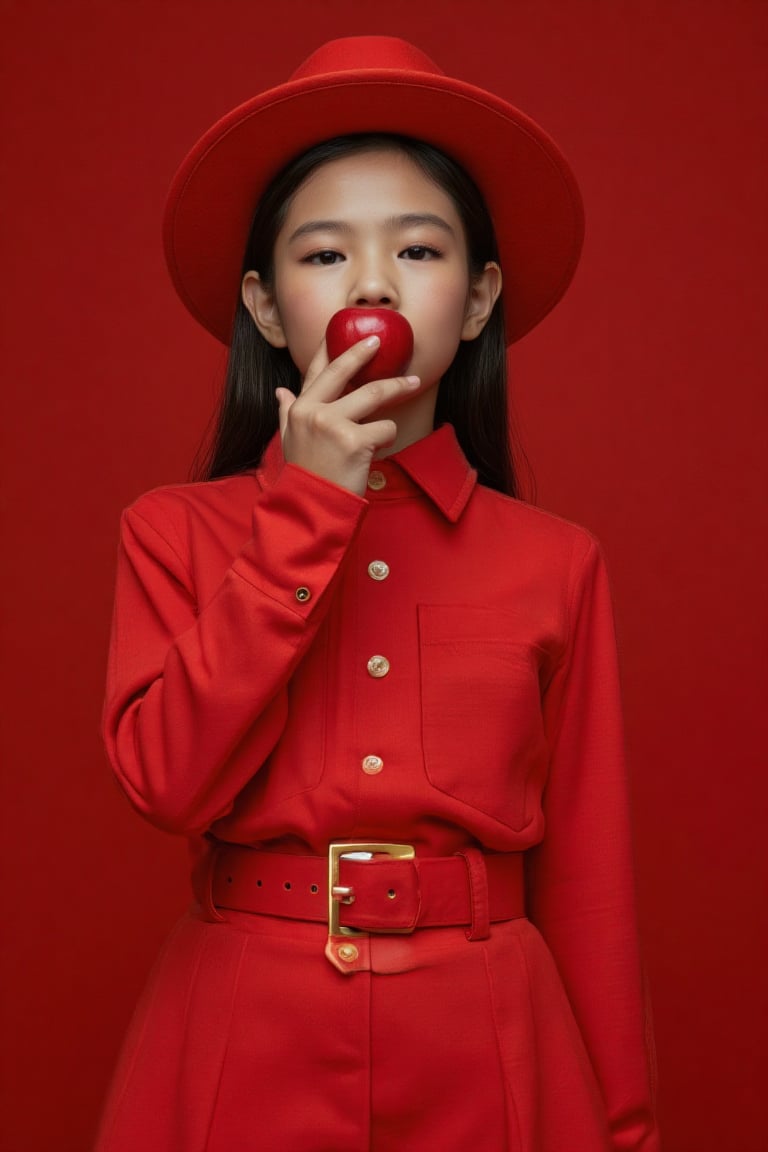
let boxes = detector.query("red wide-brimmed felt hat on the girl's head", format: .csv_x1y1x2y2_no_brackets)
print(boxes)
164,36,584,343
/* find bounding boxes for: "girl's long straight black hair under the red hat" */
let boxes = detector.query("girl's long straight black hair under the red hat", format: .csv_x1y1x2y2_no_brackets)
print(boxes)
195,132,529,495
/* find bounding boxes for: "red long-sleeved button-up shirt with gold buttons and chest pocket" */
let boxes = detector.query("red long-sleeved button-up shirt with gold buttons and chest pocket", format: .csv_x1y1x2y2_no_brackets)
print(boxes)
105,426,655,1149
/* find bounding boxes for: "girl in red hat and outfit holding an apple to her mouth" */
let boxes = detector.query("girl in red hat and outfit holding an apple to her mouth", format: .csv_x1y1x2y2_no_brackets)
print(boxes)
98,37,657,1152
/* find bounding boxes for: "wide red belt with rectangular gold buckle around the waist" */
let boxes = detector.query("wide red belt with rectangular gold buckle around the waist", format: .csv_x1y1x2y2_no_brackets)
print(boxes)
198,843,525,940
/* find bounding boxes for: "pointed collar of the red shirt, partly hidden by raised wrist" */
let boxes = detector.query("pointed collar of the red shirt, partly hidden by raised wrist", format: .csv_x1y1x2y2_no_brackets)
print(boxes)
260,424,478,524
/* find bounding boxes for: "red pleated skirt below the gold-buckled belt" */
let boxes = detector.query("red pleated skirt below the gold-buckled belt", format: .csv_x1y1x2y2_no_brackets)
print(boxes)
97,911,610,1152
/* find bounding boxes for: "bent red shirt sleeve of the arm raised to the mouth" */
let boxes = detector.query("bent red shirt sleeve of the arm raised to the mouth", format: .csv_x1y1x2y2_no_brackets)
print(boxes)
104,465,367,833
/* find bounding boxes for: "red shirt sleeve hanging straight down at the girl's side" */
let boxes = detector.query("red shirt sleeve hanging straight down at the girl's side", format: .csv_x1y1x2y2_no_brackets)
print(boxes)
529,541,659,1152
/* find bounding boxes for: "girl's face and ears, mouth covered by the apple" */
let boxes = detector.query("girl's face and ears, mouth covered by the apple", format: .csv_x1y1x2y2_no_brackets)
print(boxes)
243,150,501,391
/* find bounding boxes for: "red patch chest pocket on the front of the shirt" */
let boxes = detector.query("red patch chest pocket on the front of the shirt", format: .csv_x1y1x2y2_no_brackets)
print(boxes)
419,605,546,831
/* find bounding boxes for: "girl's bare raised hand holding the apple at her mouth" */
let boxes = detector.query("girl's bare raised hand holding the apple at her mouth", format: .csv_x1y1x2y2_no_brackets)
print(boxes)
276,336,420,495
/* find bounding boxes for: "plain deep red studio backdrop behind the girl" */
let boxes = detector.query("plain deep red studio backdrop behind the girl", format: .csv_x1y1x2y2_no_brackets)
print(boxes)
0,0,768,1152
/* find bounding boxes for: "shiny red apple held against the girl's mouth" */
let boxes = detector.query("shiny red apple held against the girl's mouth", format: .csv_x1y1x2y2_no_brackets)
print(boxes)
326,308,413,388
